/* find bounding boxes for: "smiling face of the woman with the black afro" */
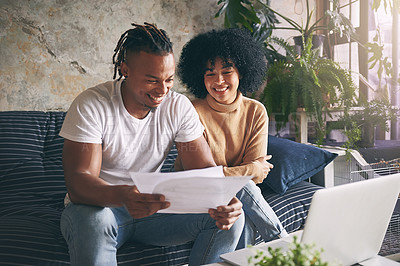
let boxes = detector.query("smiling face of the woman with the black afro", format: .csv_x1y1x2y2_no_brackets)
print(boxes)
204,57,240,104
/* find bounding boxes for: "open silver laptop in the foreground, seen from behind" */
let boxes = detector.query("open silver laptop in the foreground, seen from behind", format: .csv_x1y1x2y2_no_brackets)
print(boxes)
221,174,400,266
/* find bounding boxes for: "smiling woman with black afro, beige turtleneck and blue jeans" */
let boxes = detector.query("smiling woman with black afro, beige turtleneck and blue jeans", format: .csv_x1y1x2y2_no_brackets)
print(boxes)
175,29,287,248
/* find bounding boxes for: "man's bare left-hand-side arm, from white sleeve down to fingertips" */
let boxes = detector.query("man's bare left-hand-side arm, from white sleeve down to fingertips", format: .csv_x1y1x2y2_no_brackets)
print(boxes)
63,139,170,218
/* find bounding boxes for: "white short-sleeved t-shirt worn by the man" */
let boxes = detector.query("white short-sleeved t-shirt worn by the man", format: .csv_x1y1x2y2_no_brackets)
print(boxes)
60,81,204,185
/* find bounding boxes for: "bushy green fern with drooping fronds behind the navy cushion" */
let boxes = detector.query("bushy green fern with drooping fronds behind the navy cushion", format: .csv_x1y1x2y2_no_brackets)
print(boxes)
260,38,356,142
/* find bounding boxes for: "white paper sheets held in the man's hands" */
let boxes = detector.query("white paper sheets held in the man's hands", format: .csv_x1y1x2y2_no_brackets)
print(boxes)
130,166,252,213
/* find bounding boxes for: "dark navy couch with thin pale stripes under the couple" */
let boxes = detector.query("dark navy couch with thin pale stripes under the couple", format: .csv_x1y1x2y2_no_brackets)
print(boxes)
0,111,335,265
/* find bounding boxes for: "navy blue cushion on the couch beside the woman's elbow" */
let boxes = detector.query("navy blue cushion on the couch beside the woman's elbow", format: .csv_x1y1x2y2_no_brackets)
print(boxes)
262,136,337,195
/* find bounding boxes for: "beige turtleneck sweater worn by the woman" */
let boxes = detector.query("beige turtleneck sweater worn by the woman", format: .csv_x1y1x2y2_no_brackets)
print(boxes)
175,91,268,183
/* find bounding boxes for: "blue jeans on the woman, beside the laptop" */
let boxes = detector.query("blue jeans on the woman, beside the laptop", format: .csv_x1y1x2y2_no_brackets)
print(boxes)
236,181,287,249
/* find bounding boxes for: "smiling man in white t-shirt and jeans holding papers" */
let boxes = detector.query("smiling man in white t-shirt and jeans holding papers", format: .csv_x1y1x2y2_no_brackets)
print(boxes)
60,24,244,265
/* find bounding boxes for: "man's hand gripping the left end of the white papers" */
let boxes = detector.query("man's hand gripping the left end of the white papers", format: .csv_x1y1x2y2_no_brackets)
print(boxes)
123,186,171,219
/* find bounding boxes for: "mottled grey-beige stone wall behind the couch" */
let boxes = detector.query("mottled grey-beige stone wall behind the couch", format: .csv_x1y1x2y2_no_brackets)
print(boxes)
0,0,310,111
